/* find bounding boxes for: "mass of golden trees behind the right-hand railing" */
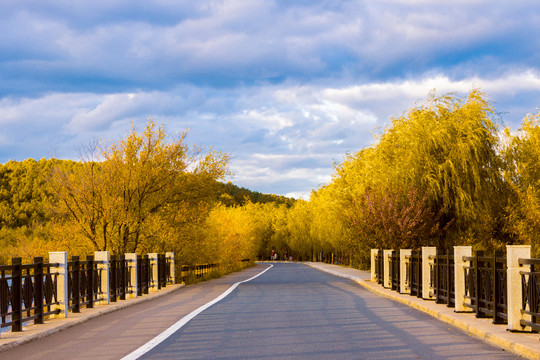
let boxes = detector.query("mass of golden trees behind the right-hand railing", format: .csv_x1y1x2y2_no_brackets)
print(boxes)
270,90,540,268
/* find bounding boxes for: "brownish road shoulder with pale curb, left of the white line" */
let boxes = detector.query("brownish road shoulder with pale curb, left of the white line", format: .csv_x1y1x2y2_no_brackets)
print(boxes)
0,265,270,360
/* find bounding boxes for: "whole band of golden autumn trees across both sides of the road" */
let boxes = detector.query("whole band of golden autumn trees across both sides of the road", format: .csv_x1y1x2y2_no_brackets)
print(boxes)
0,90,540,268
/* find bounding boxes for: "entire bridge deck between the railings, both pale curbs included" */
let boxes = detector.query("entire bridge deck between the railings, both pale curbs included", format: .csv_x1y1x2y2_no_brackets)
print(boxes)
0,262,540,360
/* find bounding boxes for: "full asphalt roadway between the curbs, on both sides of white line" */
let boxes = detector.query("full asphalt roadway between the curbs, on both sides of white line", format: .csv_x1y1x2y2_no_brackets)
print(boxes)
0,263,517,360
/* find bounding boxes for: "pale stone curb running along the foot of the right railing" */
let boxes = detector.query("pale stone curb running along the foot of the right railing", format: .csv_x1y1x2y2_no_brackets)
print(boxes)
307,263,540,359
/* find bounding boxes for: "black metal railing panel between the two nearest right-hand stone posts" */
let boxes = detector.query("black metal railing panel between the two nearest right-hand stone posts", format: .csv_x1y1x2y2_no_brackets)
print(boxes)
463,251,508,324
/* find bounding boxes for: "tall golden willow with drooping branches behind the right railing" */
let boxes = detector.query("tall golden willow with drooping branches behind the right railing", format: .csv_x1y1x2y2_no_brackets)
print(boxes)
334,90,506,253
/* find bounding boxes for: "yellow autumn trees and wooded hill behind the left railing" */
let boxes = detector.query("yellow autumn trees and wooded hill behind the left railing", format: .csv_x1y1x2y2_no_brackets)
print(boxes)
0,120,294,265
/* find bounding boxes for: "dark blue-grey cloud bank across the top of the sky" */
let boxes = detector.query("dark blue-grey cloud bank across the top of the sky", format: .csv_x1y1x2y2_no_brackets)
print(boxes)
0,0,540,92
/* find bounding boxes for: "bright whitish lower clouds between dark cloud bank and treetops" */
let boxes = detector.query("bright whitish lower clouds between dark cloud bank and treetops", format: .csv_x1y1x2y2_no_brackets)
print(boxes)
0,69,540,194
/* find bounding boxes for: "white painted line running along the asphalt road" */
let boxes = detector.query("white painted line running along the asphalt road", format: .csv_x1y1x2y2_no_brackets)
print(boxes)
121,264,274,360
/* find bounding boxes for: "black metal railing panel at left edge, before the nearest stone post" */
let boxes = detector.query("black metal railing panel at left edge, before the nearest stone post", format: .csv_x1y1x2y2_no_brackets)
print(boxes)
0,257,60,331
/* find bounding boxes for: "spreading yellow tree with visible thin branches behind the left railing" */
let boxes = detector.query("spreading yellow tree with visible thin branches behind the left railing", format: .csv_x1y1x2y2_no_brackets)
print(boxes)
51,120,228,253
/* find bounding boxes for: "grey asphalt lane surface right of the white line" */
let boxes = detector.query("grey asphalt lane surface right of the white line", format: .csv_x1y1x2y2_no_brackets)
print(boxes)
136,263,518,359
